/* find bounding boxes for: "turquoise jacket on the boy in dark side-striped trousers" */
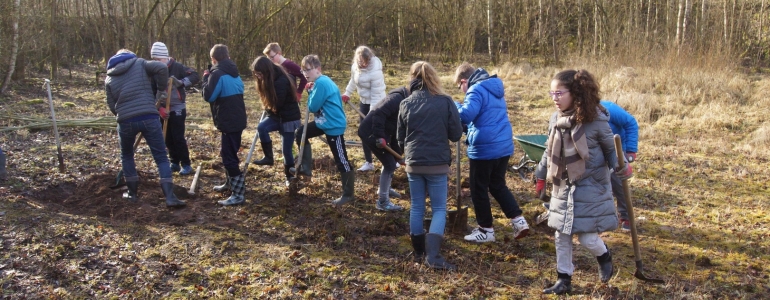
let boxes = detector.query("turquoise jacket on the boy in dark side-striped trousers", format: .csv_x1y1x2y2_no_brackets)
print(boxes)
307,75,348,136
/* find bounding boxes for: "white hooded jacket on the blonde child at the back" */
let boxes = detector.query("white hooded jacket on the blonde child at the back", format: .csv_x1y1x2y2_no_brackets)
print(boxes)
345,56,385,106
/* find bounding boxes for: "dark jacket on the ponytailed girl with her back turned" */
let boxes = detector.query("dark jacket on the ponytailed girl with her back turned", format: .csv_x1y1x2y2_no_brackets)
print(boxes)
397,85,463,166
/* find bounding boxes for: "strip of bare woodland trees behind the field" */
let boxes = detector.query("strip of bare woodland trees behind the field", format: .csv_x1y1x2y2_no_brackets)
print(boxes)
0,0,769,90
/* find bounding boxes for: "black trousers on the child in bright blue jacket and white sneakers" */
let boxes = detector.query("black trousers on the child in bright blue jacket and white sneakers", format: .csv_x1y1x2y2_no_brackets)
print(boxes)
469,156,523,228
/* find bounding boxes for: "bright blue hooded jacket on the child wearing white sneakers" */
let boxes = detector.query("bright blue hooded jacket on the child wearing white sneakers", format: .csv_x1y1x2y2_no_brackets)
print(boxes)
456,68,513,160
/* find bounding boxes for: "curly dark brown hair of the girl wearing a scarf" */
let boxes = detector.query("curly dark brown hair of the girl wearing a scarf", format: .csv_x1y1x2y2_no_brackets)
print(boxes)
553,69,607,123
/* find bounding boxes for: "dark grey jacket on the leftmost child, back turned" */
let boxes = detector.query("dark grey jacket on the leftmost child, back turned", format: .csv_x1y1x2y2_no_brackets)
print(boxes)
104,58,168,122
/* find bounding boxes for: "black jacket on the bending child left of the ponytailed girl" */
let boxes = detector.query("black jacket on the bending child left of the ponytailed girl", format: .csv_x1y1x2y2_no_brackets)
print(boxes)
358,87,409,143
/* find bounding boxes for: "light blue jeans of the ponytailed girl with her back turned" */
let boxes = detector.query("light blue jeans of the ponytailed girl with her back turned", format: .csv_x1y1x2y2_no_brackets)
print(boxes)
406,173,447,235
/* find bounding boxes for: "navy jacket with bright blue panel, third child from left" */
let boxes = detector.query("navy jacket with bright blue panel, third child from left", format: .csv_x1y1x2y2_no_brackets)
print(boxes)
202,59,246,133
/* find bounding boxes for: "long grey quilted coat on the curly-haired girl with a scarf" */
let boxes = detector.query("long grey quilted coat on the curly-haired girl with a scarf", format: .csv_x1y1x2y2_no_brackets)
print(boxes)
535,112,618,234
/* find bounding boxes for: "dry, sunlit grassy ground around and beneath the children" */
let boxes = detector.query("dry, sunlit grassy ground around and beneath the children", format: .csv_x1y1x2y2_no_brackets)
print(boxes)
0,55,770,299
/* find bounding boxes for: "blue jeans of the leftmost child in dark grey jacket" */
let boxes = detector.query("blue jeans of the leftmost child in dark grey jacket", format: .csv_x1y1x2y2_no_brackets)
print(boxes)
118,118,173,183
